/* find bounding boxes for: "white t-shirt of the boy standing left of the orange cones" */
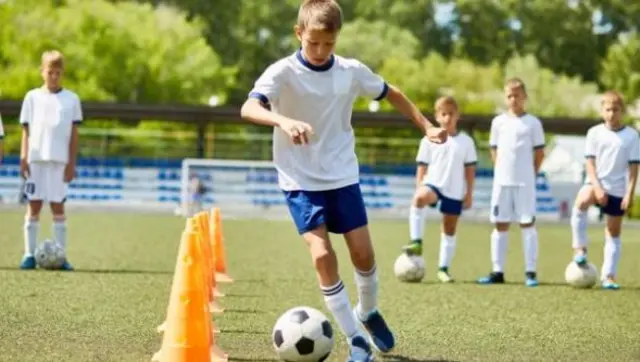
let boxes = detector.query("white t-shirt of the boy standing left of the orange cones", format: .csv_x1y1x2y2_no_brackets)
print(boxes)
20,88,82,164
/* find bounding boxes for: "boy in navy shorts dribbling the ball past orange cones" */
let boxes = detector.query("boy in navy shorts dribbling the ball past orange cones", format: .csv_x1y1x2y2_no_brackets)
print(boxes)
241,0,446,362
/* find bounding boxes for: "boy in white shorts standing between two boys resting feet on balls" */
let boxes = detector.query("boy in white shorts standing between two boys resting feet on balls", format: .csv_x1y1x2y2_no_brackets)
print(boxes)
478,78,545,287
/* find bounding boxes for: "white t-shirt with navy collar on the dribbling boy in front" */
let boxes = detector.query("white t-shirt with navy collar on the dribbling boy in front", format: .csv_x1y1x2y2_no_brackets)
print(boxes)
249,51,388,191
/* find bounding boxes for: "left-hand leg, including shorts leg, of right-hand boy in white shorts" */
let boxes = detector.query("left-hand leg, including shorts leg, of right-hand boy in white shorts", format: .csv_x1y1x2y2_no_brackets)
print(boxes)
478,184,515,284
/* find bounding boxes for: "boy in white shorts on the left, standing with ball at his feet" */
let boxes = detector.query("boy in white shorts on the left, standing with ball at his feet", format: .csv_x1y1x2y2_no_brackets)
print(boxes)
20,50,82,270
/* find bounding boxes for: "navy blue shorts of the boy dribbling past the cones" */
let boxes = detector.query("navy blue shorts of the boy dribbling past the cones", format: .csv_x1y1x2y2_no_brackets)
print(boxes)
284,184,368,235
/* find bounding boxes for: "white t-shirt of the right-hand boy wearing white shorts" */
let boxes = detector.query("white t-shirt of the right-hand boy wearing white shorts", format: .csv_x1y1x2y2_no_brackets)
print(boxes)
489,113,544,186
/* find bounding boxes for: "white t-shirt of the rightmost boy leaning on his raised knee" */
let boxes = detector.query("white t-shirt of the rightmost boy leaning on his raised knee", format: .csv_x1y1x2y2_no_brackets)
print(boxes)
584,123,640,197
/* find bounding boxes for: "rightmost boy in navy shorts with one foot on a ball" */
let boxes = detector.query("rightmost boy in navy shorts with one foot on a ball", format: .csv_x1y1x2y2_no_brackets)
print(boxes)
571,91,640,290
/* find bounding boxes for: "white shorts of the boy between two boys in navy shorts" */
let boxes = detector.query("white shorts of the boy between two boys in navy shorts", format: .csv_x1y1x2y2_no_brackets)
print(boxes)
489,184,536,224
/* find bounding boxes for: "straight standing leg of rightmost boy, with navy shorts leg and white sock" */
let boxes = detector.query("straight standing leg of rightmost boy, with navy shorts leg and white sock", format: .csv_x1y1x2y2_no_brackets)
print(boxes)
600,195,624,290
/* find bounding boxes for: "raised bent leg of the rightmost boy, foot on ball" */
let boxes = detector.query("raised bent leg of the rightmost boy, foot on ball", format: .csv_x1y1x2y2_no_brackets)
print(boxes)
571,185,595,266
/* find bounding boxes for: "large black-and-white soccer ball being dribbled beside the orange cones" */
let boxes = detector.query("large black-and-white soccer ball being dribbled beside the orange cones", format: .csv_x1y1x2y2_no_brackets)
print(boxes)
272,307,334,362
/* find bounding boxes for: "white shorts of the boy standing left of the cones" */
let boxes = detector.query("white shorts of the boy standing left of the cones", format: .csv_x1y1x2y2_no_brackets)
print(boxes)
24,162,68,203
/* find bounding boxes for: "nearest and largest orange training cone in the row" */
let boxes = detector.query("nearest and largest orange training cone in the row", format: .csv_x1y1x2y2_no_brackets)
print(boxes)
152,233,212,362
